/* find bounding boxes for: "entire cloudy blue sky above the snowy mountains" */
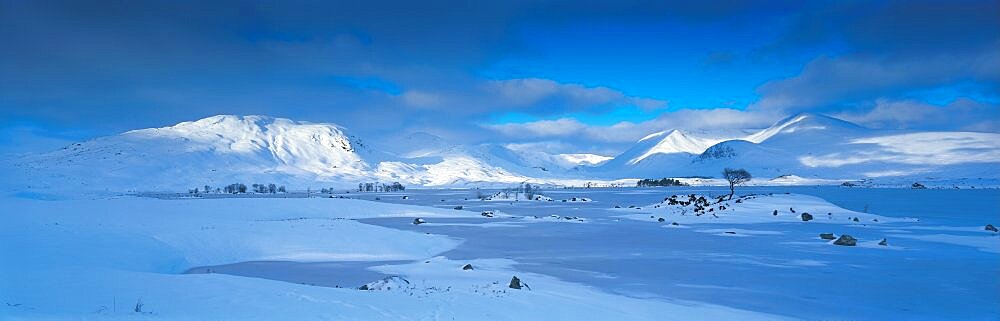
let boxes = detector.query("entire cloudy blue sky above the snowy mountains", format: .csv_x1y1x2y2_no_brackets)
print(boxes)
0,1,1000,154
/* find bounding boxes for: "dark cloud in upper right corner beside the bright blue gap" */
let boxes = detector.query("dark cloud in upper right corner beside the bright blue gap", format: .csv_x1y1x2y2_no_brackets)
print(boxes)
752,0,1000,119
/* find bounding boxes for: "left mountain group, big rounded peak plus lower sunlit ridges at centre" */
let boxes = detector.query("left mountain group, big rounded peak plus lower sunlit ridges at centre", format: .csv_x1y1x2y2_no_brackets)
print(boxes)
5,115,584,191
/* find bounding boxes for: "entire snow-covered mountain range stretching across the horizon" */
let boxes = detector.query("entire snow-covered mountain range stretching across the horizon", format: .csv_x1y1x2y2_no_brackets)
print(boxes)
9,114,1000,191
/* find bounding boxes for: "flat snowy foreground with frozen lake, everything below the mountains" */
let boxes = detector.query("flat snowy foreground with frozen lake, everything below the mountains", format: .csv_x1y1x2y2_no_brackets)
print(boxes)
0,186,1000,320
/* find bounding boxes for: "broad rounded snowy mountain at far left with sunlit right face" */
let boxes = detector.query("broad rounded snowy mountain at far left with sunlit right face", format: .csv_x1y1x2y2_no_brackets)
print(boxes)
6,115,388,191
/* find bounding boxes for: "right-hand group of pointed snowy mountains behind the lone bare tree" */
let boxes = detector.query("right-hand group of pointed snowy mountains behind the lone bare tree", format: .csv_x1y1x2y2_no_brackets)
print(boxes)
594,113,1000,179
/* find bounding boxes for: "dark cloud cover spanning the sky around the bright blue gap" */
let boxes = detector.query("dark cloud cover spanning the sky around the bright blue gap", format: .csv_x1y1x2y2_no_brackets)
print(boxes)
0,0,1000,154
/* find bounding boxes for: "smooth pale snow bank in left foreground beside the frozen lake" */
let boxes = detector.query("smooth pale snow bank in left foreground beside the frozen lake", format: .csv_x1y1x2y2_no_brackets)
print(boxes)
0,198,775,320
